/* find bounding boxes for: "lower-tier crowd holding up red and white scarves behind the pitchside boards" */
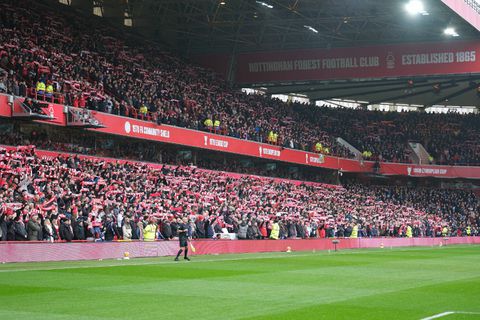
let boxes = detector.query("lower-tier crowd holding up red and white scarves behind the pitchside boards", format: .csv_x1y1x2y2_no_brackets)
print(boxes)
0,146,480,241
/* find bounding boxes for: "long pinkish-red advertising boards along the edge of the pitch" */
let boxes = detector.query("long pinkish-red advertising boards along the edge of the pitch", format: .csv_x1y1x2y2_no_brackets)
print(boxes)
0,237,480,263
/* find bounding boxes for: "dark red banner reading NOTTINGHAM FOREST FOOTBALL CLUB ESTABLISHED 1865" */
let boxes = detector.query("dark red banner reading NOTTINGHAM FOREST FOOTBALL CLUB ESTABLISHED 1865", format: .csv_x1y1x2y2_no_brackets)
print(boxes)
236,41,480,83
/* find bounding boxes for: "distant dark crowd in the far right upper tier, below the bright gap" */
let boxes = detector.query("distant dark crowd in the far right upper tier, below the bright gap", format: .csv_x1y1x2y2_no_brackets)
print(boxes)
312,107,480,165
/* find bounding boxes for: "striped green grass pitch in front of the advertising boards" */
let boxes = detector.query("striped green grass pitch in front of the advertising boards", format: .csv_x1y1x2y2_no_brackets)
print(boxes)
0,245,480,320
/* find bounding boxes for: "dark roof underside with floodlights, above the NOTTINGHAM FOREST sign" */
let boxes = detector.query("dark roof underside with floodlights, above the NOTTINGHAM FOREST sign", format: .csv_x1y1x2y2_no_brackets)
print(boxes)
57,0,478,54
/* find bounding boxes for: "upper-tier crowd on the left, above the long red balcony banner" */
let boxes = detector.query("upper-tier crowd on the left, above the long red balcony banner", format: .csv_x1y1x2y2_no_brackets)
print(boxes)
0,1,348,156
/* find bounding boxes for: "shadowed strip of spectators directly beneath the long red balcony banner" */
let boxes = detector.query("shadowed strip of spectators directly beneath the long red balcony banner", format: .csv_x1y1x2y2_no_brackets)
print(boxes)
0,127,336,183
